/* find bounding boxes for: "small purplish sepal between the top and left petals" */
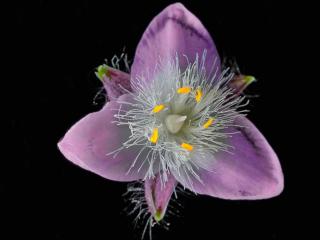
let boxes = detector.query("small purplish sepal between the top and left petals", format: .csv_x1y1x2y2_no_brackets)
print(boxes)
102,66,132,100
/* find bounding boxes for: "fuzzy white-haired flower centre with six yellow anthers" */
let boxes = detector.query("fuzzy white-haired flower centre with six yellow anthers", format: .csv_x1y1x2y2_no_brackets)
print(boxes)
112,57,247,185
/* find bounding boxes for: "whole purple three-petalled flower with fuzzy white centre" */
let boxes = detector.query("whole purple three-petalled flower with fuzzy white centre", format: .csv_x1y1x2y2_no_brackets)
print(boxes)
58,3,283,230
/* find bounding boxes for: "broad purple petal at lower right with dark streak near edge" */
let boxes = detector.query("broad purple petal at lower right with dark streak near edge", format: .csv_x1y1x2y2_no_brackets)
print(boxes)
173,117,283,199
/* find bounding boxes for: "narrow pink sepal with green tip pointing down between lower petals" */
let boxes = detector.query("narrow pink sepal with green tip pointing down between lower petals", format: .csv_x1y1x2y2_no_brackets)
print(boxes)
144,173,177,222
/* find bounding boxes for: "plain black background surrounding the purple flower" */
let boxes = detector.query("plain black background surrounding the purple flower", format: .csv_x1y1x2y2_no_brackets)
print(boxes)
4,0,302,240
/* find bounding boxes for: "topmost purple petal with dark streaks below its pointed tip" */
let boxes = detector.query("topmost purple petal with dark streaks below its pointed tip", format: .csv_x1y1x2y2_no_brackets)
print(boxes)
131,3,220,80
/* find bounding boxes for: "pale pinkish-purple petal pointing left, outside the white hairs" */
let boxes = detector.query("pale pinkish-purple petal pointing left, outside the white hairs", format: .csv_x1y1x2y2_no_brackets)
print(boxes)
58,95,148,181
